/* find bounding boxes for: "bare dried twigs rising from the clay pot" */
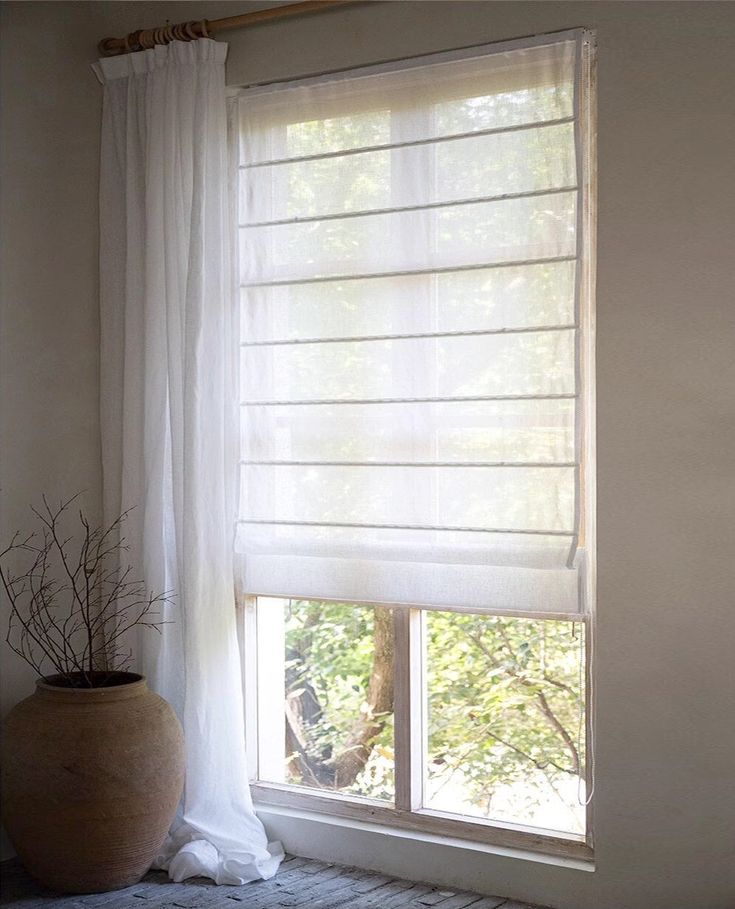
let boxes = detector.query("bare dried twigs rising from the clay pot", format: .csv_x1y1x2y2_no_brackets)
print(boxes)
0,496,172,688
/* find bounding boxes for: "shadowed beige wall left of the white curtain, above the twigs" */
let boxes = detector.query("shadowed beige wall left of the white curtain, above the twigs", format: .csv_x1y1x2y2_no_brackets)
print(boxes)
0,3,105,732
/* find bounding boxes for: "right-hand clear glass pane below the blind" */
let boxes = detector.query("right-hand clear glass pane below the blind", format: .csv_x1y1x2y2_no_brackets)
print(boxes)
425,612,585,833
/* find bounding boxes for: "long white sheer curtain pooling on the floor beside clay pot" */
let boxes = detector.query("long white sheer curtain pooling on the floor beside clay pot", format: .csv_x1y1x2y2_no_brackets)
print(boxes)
96,39,280,884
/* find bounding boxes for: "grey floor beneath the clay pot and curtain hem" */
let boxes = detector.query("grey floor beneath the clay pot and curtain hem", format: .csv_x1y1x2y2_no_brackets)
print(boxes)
0,856,552,909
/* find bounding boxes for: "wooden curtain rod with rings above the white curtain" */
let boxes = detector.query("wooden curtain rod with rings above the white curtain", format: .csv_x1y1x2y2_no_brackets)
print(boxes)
97,0,357,57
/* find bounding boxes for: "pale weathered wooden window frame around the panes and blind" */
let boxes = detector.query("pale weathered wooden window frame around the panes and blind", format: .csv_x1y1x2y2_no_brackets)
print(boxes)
236,29,596,861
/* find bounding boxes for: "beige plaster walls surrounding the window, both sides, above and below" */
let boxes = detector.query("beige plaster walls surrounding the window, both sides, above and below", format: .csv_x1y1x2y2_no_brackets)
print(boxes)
2,0,735,909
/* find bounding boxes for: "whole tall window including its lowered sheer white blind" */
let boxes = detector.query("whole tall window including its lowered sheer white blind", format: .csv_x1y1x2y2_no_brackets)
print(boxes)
236,24,594,855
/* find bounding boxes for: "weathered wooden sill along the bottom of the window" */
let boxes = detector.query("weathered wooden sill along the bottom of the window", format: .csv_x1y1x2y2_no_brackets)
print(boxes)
253,783,595,871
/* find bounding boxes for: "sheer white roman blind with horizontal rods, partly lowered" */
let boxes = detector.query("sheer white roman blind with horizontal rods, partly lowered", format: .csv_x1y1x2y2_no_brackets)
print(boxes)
236,32,586,614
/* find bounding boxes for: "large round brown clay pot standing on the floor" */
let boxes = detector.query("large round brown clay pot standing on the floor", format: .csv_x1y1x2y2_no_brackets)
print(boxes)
2,672,184,893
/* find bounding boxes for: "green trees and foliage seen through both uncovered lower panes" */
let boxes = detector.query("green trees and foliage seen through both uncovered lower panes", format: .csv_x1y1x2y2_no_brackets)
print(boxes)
286,601,584,832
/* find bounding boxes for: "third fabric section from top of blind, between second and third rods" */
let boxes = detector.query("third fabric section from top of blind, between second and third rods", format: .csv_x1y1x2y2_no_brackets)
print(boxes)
240,193,577,285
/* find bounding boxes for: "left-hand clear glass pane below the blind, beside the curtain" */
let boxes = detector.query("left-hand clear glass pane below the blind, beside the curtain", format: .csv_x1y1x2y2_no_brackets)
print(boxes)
258,597,394,801
